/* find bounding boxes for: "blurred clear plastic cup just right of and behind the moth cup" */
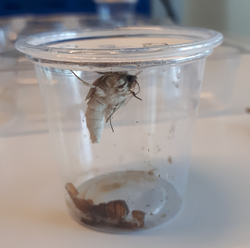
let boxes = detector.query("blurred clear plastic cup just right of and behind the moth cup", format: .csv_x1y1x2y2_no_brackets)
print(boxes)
198,40,242,117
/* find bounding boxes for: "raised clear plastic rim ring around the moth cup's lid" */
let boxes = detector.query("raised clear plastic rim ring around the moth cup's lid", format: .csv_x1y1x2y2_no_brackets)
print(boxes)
16,27,223,61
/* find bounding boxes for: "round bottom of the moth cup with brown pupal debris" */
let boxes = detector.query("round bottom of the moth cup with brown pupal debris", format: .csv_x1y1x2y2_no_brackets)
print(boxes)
66,171,182,233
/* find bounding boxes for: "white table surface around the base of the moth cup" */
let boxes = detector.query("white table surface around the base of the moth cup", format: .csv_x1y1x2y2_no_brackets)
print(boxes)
0,55,250,248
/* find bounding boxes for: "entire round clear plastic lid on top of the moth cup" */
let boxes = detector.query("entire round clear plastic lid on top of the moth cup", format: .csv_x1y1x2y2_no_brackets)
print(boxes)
16,27,223,68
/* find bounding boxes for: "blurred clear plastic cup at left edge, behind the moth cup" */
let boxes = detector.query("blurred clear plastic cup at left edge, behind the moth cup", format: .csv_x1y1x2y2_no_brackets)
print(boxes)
0,50,48,137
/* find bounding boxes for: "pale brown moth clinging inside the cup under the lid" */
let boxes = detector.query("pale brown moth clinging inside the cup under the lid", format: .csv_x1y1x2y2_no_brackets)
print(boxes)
71,71,141,144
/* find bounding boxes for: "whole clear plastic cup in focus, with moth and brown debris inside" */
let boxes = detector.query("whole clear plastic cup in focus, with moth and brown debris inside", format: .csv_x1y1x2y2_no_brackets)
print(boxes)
16,27,222,232
